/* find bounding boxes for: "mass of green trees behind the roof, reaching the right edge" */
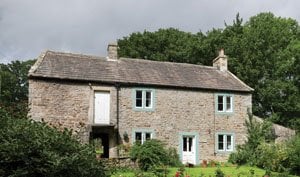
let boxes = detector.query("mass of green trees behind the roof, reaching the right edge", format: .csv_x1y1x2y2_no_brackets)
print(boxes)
118,13,300,130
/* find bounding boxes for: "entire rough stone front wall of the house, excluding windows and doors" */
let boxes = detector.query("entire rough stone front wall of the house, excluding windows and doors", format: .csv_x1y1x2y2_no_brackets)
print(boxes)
29,79,251,162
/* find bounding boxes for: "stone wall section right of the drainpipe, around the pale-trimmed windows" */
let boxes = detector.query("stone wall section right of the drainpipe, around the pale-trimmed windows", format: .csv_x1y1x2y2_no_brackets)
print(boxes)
119,88,251,162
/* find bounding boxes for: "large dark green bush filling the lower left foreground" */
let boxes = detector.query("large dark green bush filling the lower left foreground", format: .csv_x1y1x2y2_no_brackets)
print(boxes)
0,109,106,177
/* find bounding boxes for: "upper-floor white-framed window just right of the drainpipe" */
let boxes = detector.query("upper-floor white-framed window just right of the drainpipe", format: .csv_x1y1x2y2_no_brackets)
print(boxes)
133,89,154,110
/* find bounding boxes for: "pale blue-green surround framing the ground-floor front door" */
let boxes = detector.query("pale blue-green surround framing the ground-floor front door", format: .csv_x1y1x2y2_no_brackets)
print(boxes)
178,132,200,165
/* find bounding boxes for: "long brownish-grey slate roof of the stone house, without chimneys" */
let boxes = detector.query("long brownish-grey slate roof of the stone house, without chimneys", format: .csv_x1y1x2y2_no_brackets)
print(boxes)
29,51,253,92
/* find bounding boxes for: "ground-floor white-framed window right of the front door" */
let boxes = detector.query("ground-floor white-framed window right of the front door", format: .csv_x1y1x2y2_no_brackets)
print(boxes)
217,134,233,152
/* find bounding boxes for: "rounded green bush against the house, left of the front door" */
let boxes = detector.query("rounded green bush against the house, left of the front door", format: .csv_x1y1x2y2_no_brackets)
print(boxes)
130,139,170,171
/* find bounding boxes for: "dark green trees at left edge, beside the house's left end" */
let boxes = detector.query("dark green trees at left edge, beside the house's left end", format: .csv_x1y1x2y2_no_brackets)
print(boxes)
0,60,35,118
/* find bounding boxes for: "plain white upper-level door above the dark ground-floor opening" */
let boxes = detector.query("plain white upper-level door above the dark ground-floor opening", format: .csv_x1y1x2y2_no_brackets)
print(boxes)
94,92,110,124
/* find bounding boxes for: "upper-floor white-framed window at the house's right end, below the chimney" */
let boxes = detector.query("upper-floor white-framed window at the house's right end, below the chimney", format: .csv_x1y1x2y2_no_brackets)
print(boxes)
216,94,233,113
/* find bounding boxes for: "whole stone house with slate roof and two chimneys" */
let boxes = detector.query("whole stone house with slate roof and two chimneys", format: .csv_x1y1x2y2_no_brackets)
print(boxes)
29,44,253,164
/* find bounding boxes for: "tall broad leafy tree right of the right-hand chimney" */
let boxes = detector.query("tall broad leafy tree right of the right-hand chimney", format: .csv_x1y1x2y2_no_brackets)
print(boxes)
233,13,300,129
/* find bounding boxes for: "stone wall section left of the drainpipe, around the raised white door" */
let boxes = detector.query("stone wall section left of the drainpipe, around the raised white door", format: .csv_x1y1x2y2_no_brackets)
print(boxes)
29,79,117,157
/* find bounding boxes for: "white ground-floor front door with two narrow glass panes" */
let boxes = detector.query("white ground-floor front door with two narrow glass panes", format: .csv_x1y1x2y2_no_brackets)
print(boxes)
182,136,196,164
